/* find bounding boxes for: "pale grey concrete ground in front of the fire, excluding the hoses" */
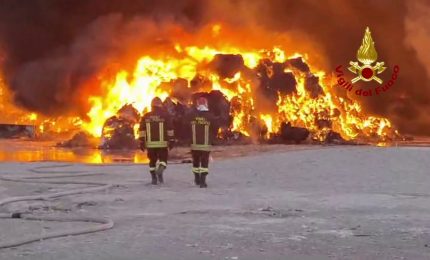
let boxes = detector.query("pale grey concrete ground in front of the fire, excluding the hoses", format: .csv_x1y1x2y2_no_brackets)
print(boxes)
0,146,430,260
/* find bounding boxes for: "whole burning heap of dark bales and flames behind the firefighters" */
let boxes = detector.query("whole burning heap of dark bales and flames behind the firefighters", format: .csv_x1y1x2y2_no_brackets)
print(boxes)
0,22,397,149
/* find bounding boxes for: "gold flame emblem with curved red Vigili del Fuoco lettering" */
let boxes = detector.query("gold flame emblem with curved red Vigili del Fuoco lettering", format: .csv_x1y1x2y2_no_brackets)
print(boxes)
336,27,400,96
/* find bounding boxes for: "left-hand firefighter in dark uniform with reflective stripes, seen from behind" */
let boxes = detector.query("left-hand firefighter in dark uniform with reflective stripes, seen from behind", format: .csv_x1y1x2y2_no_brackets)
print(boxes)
139,97,174,185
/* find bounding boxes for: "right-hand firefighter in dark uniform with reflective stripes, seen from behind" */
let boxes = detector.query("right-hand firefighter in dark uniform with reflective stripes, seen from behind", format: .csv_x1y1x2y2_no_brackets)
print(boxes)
188,97,218,188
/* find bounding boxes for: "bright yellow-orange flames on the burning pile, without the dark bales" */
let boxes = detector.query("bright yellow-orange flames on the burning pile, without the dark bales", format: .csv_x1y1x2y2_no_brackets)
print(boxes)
84,45,391,139
